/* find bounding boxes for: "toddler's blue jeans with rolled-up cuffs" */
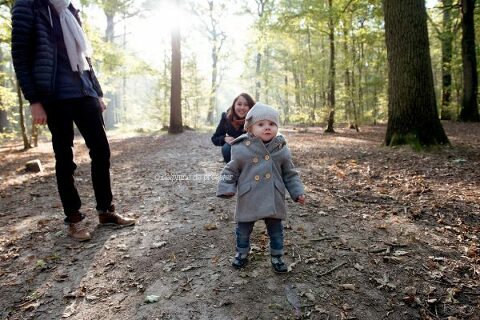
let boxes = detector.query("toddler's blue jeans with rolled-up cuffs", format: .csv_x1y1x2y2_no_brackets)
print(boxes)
235,218,283,255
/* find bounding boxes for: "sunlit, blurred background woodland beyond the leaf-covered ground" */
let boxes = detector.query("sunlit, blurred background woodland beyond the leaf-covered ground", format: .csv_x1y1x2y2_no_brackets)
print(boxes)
0,0,480,146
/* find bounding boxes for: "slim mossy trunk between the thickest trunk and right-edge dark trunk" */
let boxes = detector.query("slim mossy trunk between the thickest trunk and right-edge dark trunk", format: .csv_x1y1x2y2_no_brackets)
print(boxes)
440,0,453,120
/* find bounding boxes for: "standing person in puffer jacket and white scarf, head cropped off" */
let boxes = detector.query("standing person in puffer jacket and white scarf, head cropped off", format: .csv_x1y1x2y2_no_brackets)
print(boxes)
12,0,136,241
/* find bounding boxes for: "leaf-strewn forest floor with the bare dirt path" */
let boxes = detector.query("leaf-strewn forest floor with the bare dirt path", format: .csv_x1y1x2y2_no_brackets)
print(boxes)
0,122,480,320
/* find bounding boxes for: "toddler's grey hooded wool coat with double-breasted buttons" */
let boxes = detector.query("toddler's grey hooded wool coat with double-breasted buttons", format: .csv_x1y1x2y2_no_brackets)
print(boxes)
217,134,304,222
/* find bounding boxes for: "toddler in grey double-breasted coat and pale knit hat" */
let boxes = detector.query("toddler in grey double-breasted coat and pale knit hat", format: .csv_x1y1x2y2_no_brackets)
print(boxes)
217,102,305,273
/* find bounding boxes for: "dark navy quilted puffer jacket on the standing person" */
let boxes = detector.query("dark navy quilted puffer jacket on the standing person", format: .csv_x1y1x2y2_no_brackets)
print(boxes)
12,0,103,103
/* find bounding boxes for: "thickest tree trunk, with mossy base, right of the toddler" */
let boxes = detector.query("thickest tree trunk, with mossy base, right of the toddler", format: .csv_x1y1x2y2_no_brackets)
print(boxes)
383,0,448,148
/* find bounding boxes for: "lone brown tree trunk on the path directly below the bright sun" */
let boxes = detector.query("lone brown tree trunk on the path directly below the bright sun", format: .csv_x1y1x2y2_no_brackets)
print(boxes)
168,21,183,133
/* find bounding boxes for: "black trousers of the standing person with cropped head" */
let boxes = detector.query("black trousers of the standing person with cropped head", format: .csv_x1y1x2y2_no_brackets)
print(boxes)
44,97,112,222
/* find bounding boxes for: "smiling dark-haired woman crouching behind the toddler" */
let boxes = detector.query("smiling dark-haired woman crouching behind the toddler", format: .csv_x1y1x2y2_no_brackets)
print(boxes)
212,93,255,163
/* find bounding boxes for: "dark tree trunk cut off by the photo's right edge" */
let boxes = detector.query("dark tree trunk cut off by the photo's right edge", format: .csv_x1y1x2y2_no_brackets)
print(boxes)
459,0,480,122
